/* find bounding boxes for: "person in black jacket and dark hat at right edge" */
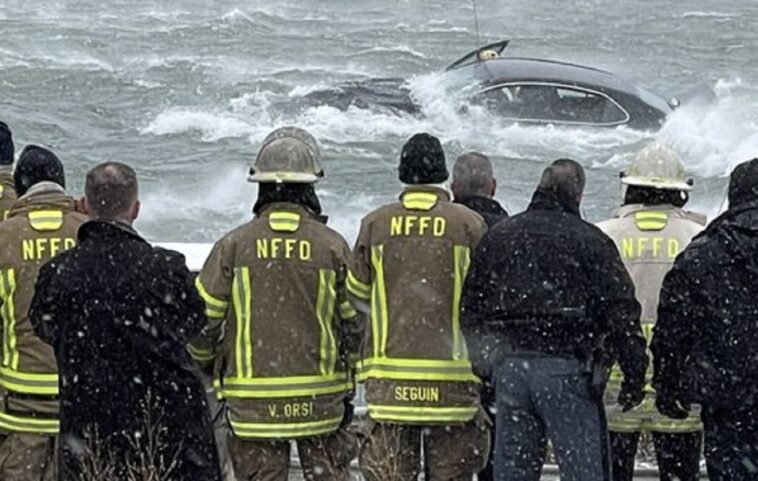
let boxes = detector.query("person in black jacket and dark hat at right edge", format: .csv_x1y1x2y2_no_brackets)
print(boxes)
650,159,758,481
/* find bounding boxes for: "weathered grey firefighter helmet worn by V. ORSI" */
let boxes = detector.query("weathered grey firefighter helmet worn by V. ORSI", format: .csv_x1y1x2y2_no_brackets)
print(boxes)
247,127,324,184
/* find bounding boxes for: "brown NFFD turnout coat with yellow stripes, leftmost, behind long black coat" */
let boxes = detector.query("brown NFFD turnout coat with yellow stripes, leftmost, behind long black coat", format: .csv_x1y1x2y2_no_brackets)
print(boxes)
0,182,86,434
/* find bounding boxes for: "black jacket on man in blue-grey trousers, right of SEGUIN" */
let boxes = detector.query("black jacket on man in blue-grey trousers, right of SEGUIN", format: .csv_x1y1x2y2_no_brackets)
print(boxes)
461,190,647,386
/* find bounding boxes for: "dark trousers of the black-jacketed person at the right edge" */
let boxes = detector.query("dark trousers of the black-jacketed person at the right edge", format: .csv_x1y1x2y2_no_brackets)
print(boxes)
702,406,758,481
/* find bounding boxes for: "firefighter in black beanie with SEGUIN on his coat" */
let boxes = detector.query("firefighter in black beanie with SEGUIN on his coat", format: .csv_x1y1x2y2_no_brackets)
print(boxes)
347,133,489,481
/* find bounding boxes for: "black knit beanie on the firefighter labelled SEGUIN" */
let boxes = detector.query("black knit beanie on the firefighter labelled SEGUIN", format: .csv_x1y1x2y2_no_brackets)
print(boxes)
399,133,449,184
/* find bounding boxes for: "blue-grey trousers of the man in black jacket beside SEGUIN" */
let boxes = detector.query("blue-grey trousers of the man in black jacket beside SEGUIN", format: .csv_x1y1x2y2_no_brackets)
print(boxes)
495,353,610,481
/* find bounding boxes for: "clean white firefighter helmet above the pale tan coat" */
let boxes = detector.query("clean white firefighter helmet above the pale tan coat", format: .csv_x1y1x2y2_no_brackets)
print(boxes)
621,143,693,191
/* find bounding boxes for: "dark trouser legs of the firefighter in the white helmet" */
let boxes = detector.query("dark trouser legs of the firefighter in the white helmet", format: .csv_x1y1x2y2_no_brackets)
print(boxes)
610,431,703,481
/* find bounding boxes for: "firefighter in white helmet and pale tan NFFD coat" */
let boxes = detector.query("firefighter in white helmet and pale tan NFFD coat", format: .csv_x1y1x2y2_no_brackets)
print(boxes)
598,143,706,481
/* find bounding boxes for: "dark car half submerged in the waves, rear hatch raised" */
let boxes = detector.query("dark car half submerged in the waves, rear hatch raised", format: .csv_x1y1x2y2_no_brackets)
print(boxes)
300,40,678,130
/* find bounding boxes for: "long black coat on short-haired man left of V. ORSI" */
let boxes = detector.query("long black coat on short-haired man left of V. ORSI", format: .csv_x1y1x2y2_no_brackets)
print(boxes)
30,221,220,481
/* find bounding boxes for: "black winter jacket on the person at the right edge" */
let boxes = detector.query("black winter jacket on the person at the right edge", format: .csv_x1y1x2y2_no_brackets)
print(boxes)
651,201,758,411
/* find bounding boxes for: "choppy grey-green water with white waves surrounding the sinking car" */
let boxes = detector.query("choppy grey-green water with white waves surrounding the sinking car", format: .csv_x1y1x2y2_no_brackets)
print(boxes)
0,0,758,241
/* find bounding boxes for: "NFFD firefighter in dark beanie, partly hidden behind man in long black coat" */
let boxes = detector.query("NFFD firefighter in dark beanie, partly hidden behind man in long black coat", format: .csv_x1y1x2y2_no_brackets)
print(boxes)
0,145,85,481
